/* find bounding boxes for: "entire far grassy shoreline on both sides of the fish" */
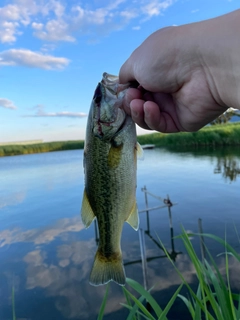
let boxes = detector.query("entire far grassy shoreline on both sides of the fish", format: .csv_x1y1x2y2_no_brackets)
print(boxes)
0,122,240,157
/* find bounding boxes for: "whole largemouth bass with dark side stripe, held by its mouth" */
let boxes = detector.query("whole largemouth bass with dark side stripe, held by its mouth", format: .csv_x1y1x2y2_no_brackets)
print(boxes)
81,72,143,286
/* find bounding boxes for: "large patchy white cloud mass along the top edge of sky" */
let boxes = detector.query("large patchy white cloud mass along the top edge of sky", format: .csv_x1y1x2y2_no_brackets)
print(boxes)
0,0,177,43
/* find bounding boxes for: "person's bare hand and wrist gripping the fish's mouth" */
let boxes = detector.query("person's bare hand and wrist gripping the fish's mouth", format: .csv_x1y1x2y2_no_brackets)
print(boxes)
119,10,240,132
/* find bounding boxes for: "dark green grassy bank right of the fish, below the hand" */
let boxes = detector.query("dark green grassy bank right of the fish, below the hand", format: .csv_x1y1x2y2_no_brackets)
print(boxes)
138,122,240,147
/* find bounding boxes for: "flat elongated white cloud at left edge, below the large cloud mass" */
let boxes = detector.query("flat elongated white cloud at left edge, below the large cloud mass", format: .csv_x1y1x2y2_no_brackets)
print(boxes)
0,49,70,70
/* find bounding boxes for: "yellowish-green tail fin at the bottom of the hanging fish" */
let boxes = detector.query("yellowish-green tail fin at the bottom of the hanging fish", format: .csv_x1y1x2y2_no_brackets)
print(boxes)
89,250,126,286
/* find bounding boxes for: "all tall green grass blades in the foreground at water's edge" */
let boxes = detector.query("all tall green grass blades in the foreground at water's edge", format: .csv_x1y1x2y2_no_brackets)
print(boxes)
98,229,240,320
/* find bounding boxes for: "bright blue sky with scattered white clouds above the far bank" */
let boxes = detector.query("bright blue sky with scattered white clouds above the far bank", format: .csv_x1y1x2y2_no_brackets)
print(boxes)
0,0,239,143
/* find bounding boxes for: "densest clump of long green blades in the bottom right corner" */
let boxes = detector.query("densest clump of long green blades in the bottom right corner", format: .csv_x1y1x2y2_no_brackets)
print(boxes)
166,229,240,320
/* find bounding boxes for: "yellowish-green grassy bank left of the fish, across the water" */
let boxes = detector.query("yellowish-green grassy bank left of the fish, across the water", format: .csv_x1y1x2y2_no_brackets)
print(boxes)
0,140,84,157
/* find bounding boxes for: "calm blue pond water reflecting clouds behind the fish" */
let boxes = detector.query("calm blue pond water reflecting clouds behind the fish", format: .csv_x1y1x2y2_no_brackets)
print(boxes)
0,148,240,320
